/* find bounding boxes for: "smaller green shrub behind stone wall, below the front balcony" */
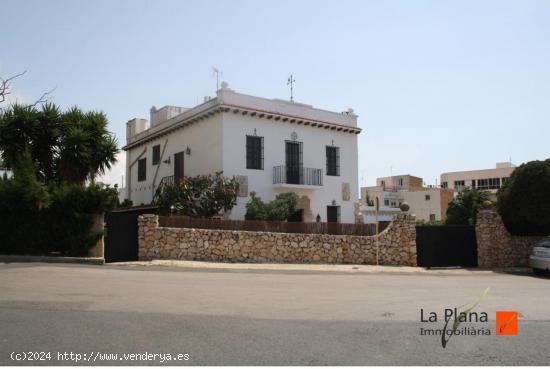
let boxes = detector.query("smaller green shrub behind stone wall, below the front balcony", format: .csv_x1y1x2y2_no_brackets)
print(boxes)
245,192,298,221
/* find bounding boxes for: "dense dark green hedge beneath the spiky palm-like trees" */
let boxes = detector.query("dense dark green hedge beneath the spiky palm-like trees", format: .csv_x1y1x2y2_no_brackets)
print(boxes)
0,177,118,256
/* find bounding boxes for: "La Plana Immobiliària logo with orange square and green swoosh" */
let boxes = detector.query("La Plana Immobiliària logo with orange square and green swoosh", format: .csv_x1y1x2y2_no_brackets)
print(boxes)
420,288,518,348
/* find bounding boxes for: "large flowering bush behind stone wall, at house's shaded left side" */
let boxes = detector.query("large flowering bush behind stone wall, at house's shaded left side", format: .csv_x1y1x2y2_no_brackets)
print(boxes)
155,172,239,218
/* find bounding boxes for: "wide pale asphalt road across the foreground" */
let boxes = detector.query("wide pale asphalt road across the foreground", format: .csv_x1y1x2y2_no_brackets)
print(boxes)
0,264,550,365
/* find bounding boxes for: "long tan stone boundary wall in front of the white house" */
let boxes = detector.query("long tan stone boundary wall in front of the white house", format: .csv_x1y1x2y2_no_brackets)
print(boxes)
138,213,416,266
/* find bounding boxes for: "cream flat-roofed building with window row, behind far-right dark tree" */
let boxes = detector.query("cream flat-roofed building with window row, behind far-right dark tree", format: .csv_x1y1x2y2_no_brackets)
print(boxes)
441,162,516,199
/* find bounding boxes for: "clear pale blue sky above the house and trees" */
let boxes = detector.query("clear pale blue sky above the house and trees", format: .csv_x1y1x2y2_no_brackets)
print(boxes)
0,0,550,185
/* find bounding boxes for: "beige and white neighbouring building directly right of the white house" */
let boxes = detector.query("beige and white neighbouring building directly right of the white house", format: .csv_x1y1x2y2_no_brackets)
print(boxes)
361,175,453,221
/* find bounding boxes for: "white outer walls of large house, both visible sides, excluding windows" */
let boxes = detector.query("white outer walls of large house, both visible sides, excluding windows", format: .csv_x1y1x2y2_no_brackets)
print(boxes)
125,84,360,223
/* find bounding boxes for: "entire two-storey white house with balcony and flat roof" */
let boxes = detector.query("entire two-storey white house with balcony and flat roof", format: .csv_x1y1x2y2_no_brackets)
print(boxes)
124,82,361,223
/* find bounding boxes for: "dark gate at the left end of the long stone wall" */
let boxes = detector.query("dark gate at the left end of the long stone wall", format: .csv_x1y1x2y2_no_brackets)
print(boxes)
105,207,157,263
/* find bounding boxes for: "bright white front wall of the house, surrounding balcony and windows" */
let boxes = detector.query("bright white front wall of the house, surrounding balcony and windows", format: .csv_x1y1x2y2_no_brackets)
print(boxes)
223,112,359,223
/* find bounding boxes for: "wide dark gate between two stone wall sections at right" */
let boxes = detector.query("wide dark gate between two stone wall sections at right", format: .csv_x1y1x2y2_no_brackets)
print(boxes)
416,225,477,267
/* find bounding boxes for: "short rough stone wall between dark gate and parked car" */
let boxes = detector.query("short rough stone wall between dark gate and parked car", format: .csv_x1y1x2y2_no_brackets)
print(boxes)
476,209,543,268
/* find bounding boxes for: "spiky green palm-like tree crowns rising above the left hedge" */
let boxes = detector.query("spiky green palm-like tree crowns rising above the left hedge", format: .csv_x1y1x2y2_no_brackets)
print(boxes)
0,104,118,184
